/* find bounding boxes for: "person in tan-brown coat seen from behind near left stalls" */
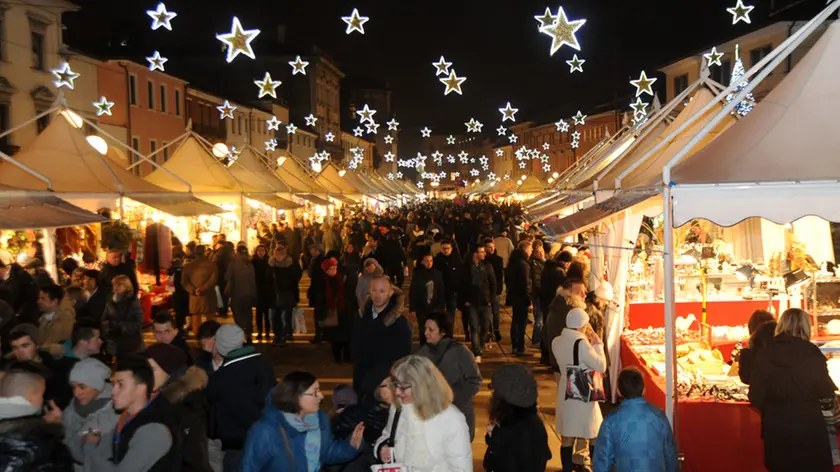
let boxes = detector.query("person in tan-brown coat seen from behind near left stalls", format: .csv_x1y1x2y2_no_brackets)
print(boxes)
181,246,222,334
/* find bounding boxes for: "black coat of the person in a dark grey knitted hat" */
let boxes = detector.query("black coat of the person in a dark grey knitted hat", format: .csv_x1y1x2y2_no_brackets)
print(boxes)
484,407,551,472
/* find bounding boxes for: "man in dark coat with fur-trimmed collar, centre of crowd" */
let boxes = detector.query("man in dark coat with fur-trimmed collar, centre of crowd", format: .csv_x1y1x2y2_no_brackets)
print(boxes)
351,275,412,399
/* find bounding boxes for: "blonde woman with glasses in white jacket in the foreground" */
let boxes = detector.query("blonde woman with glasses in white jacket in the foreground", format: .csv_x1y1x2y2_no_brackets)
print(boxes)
373,356,473,472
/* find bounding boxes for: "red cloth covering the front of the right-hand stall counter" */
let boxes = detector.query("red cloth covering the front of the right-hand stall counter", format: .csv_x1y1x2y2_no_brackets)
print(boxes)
621,338,840,472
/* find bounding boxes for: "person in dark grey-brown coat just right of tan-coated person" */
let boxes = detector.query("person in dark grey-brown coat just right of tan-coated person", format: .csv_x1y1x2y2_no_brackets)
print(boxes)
223,246,257,344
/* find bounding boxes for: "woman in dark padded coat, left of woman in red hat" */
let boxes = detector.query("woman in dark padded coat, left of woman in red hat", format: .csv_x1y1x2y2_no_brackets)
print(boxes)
268,244,303,346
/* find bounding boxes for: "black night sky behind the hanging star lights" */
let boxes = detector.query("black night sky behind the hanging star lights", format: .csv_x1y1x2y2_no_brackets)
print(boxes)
65,0,825,134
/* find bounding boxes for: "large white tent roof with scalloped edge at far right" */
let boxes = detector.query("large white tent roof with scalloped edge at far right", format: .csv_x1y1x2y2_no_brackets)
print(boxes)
671,22,840,226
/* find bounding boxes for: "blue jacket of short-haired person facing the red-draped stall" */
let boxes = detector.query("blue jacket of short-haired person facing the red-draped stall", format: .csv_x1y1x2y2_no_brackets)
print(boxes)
592,398,677,472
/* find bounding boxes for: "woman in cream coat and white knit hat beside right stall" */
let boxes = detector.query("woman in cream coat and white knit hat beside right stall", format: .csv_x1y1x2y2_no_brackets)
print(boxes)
551,308,607,470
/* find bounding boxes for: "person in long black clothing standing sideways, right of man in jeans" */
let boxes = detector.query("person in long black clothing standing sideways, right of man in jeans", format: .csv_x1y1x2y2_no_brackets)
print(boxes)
507,240,533,357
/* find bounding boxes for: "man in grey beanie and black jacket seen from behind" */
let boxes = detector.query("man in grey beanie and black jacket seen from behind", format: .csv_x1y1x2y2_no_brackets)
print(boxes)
207,324,277,470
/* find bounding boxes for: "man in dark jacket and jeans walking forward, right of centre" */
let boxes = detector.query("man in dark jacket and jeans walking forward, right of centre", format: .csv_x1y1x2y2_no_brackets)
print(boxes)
458,246,496,363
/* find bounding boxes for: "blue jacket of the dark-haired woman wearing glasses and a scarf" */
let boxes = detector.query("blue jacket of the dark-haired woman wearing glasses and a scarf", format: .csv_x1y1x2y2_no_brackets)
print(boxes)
241,394,359,472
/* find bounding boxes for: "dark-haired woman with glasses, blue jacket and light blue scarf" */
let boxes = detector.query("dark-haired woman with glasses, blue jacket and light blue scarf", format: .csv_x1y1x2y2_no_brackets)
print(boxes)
241,372,364,472
